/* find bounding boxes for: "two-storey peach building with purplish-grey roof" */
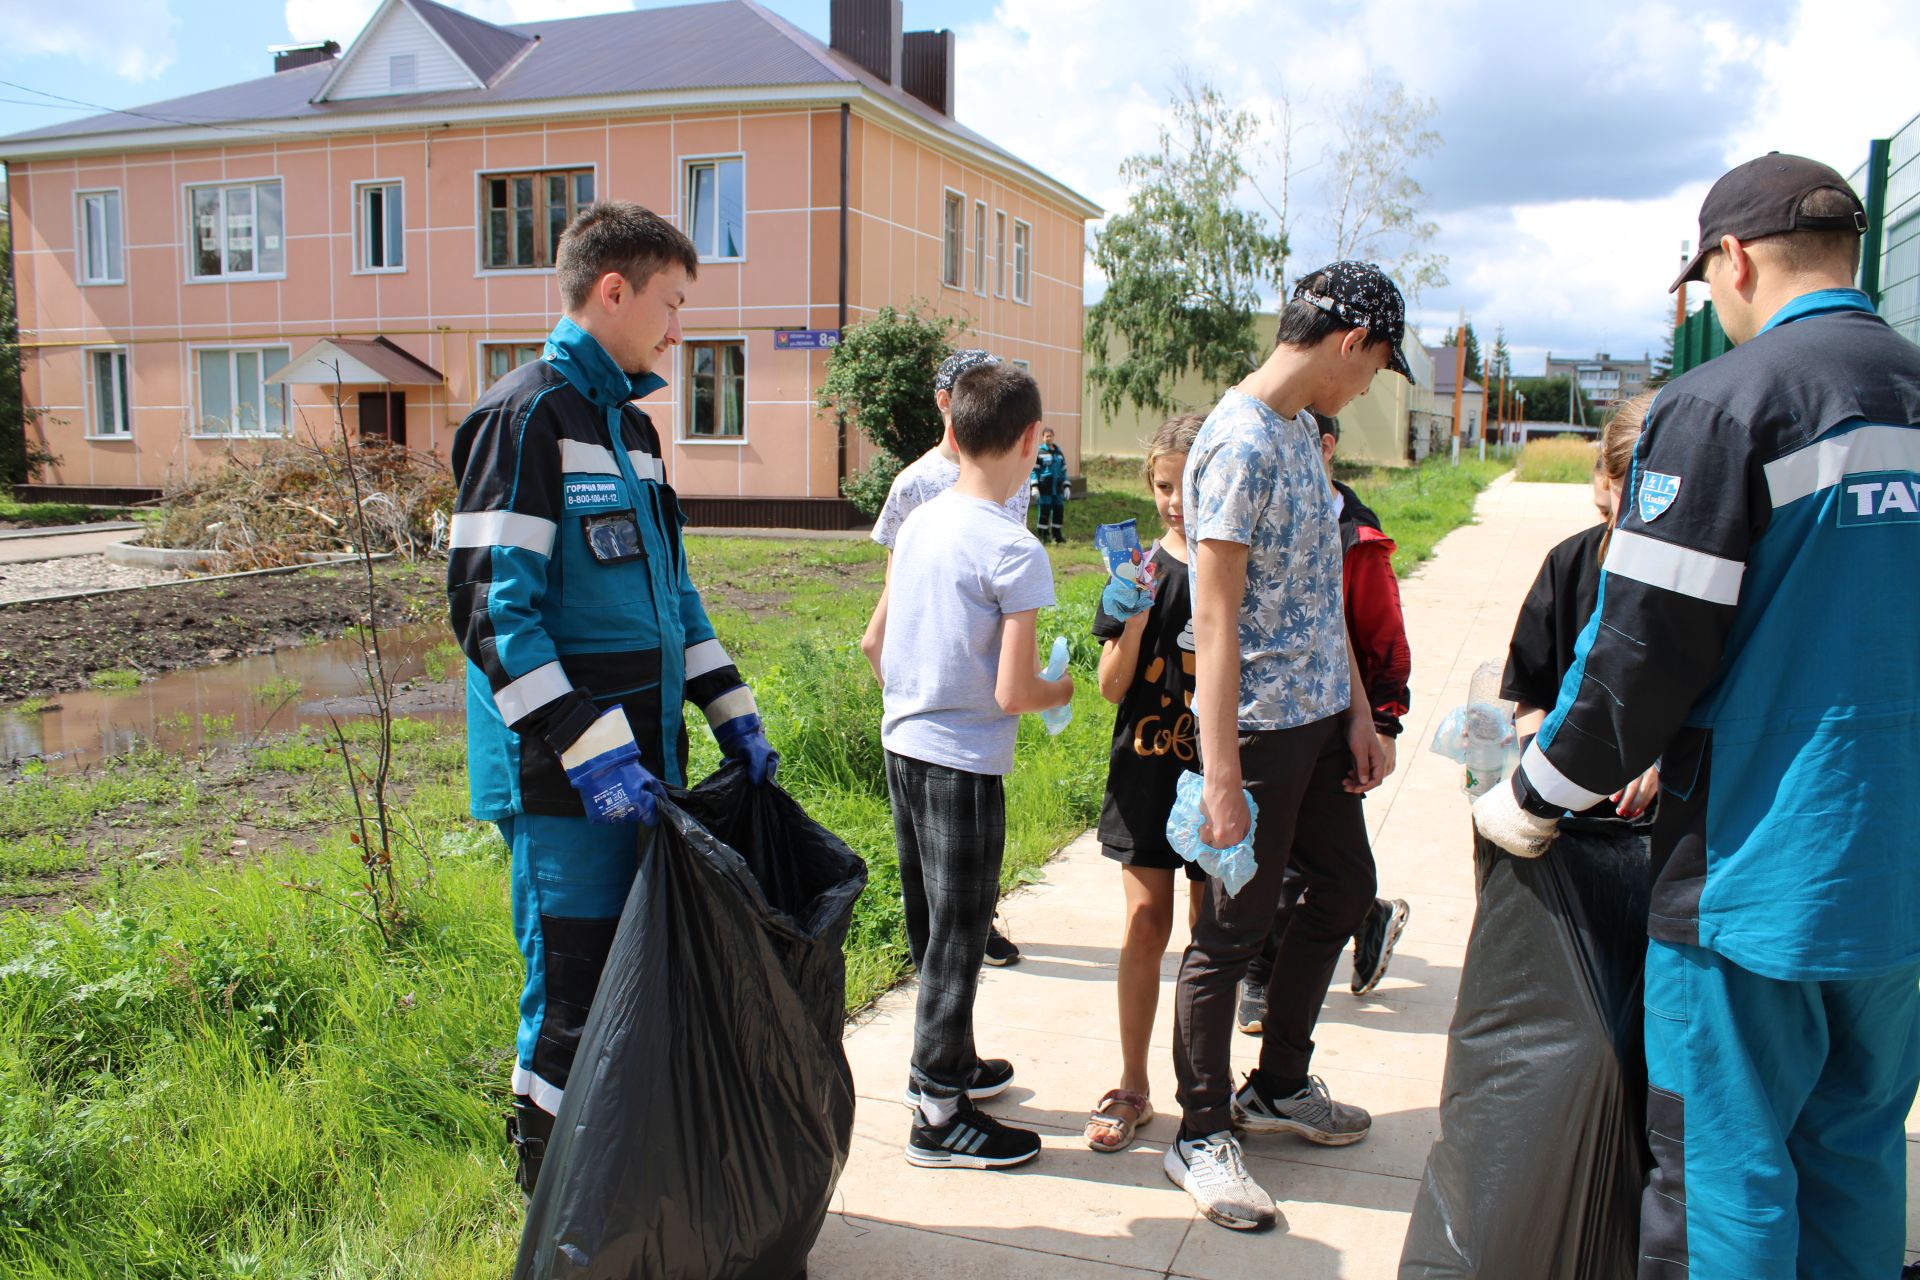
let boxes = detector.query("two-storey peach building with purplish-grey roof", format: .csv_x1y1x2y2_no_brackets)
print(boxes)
0,0,1100,524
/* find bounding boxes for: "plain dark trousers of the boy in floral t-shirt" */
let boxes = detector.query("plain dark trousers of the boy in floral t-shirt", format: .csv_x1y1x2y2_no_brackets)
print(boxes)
1173,716,1375,1134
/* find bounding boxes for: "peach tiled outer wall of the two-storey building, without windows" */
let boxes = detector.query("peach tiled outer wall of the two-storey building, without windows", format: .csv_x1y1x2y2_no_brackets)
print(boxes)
10,106,1083,497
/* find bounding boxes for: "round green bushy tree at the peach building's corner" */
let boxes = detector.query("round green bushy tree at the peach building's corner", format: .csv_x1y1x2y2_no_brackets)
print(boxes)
816,301,960,462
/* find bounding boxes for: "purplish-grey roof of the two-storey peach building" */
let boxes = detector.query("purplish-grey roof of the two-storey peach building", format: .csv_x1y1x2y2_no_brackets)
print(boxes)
0,0,1102,217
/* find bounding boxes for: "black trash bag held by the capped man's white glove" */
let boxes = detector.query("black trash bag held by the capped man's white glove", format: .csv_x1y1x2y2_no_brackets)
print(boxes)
1400,818,1649,1280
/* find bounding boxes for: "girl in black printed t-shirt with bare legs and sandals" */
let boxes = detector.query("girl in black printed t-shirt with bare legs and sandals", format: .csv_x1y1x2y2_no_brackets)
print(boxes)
1087,413,1206,1151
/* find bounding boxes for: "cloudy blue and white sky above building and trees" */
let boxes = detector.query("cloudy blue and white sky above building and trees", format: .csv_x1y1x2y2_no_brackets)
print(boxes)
0,0,1920,372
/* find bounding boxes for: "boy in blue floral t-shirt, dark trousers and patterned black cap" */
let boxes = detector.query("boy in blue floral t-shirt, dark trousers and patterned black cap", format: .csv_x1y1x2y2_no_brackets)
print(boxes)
1165,263,1411,1230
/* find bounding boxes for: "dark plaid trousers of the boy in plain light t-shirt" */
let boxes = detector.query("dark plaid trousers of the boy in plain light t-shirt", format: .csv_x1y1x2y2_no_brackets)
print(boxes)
887,750,1006,1098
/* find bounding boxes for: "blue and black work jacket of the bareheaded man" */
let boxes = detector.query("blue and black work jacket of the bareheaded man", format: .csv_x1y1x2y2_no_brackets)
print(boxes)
447,319,755,819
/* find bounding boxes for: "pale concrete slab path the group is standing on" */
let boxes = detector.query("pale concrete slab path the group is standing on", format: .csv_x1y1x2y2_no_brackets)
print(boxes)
808,478,1920,1280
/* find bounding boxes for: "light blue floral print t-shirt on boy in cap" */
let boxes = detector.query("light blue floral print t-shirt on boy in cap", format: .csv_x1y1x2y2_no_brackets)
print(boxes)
1181,391,1354,731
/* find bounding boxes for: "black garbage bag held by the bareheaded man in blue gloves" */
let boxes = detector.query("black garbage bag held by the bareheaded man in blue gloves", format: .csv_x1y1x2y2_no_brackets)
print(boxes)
515,764,866,1280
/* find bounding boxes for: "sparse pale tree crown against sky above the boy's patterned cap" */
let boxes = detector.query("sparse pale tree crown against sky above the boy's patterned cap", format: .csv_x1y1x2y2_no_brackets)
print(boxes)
1321,75,1448,301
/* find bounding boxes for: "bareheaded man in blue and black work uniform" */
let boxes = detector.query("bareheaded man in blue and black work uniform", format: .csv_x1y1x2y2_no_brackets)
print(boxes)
447,201,780,1194
